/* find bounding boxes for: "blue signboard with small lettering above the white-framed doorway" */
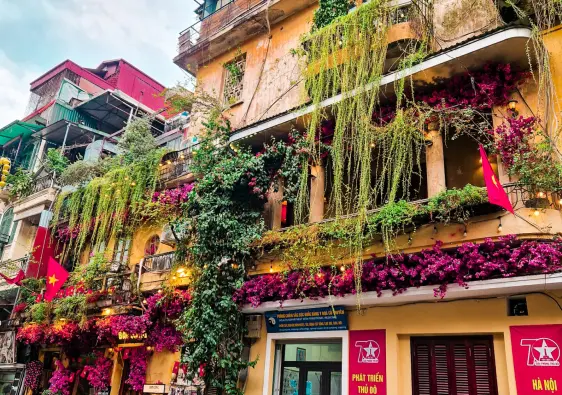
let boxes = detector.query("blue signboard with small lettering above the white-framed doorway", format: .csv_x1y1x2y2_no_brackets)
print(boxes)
265,306,347,333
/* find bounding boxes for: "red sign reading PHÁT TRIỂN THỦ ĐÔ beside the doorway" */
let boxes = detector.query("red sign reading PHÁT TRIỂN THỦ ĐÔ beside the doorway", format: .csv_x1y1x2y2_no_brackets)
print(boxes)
349,329,386,395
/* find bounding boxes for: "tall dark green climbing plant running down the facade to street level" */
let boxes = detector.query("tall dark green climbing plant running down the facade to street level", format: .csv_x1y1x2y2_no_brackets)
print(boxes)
176,114,270,394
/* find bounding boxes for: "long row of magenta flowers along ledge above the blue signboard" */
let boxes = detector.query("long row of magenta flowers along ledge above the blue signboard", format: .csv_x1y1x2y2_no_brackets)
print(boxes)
234,235,562,307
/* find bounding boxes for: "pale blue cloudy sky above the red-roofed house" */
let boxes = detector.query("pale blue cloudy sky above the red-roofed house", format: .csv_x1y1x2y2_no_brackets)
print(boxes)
0,0,196,127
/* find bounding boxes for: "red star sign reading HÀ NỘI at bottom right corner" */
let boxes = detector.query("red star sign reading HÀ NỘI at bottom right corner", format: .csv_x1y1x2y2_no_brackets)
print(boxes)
510,325,562,395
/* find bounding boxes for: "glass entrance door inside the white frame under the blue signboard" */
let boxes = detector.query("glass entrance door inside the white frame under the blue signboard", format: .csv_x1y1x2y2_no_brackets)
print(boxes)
276,343,342,395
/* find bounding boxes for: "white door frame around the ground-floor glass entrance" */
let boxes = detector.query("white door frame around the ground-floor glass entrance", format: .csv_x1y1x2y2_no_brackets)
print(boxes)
263,330,349,395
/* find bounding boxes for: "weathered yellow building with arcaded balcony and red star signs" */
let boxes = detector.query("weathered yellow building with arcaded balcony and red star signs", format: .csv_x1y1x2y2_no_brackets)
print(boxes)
6,0,562,395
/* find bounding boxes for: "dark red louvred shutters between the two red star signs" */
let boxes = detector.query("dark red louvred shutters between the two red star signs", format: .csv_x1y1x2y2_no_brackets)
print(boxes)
412,336,498,395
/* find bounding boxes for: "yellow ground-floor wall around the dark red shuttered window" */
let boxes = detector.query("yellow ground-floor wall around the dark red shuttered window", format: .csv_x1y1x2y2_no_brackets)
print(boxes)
245,293,562,395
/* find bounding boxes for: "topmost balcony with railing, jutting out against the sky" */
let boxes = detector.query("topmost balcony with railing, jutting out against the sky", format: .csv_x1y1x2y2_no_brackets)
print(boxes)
174,0,317,75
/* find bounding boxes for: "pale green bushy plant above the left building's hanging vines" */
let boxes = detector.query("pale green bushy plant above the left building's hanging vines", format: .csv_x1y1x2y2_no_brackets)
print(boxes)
117,117,156,164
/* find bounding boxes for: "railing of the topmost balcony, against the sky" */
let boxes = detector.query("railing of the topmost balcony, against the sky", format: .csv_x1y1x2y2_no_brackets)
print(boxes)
178,0,268,54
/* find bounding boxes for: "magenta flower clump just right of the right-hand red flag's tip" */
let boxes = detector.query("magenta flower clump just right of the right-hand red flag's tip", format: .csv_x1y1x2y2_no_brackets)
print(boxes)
491,116,537,167
